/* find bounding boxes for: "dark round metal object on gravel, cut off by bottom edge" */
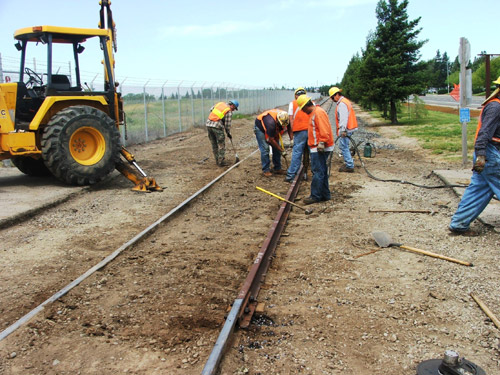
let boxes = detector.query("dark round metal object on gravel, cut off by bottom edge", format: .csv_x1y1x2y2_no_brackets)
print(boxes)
417,350,486,375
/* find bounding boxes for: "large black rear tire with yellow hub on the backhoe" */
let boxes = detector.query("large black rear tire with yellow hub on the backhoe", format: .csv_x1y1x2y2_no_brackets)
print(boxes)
42,105,121,186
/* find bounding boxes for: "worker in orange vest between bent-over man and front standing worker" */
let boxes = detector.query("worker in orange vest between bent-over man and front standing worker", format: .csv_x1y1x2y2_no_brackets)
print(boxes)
285,87,311,182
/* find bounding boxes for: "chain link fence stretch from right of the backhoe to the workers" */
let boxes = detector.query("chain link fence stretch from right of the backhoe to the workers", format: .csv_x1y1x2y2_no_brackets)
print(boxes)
120,82,293,144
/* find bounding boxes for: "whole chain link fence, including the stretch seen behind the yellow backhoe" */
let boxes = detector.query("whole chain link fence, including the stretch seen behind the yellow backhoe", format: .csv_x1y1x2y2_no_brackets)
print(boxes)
0,54,319,146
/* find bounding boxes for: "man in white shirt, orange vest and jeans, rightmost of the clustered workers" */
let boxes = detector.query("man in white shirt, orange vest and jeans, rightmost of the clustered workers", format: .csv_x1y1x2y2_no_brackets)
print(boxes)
328,87,358,173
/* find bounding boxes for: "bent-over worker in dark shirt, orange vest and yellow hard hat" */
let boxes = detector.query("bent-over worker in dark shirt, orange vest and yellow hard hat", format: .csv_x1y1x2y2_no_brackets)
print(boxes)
254,109,293,177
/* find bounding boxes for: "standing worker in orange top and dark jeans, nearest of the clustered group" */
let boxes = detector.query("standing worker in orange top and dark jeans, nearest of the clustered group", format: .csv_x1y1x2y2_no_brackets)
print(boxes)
297,95,334,204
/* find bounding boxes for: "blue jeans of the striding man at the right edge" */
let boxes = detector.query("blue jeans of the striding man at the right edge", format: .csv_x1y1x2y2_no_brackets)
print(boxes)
450,144,500,231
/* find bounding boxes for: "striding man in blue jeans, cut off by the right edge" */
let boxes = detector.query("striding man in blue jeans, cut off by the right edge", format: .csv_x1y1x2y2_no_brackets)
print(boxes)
449,77,500,236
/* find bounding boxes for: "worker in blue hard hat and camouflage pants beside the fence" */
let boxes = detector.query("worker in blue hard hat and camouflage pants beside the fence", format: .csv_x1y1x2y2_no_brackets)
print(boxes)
205,100,240,167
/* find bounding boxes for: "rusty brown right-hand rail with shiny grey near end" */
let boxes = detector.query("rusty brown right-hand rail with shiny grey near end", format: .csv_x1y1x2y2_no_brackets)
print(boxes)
202,165,303,375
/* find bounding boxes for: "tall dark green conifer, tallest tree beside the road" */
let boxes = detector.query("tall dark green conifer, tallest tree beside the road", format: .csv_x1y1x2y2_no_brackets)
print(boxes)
363,0,426,124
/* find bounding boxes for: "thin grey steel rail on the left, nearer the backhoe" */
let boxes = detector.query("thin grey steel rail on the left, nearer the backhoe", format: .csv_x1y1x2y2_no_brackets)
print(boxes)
0,149,259,341
